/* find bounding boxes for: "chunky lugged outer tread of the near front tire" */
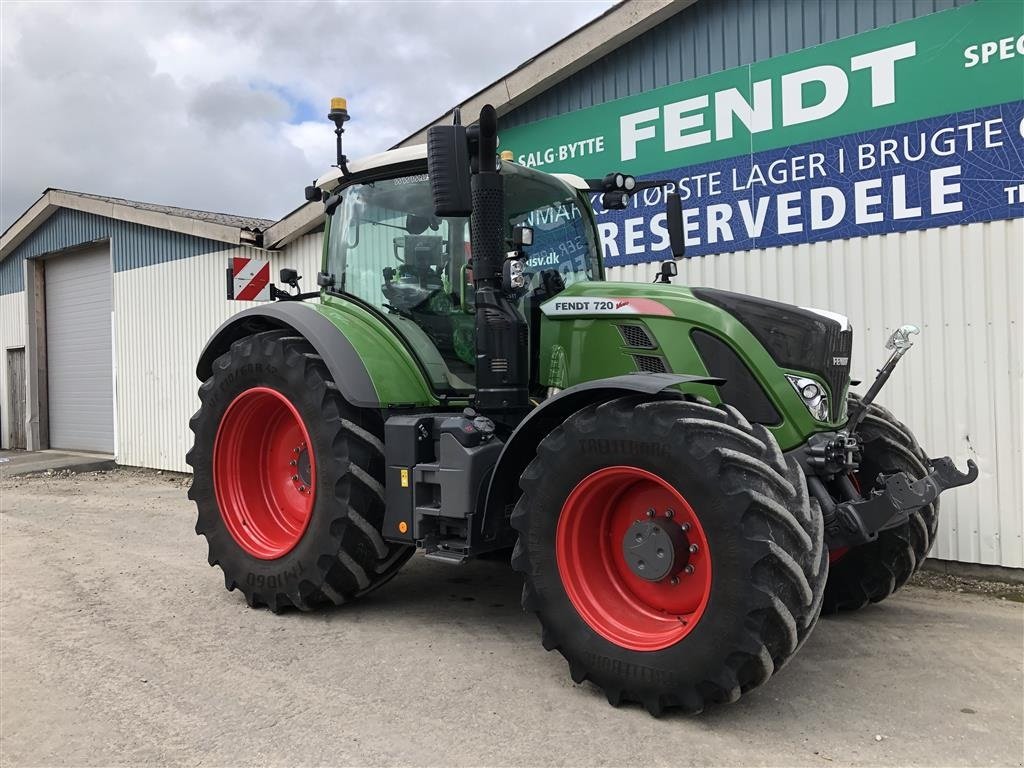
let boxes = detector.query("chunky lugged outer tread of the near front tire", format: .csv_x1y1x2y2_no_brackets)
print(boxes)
510,397,827,716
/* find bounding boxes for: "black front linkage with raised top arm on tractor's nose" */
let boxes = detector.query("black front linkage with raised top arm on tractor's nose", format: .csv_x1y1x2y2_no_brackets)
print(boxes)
793,326,978,550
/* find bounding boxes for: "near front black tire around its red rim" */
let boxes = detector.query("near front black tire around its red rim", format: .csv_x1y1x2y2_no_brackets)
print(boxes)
511,397,828,716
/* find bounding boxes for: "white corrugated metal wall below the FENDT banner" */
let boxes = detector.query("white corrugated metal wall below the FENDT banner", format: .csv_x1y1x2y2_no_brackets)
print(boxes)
608,219,1024,567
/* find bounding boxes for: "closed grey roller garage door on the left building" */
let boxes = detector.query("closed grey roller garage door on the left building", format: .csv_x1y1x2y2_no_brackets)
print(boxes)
46,243,114,454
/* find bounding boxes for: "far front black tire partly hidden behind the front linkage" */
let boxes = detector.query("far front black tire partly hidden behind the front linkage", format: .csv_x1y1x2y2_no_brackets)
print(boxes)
822,395,939,613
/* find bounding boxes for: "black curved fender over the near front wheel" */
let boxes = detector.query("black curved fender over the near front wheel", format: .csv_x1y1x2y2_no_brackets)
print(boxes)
481,374,725,538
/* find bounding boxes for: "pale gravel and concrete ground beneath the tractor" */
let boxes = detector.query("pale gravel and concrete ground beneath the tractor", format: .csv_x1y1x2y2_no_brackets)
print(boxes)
0,470,1024,766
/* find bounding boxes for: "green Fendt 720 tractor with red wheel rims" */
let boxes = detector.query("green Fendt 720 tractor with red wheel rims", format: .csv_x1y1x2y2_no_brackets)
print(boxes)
187,99,977,714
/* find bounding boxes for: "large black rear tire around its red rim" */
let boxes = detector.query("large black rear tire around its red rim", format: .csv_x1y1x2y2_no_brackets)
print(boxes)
186,331,414,612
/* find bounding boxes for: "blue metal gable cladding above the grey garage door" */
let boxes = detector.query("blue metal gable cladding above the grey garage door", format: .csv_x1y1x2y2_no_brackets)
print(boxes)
0,208,236,295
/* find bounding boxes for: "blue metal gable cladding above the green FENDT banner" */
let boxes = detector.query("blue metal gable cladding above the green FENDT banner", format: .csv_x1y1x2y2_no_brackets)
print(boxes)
501,0,973,128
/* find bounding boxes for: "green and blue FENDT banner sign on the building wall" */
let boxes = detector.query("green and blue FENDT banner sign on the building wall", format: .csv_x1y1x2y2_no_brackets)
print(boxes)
501,0,1024,266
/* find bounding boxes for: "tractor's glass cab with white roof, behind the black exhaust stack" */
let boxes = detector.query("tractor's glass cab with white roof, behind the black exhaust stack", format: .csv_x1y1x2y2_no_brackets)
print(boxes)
317,152,603,394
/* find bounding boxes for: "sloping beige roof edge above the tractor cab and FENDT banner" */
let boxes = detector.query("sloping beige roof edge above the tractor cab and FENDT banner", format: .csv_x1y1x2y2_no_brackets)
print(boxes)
395,0,696,147
